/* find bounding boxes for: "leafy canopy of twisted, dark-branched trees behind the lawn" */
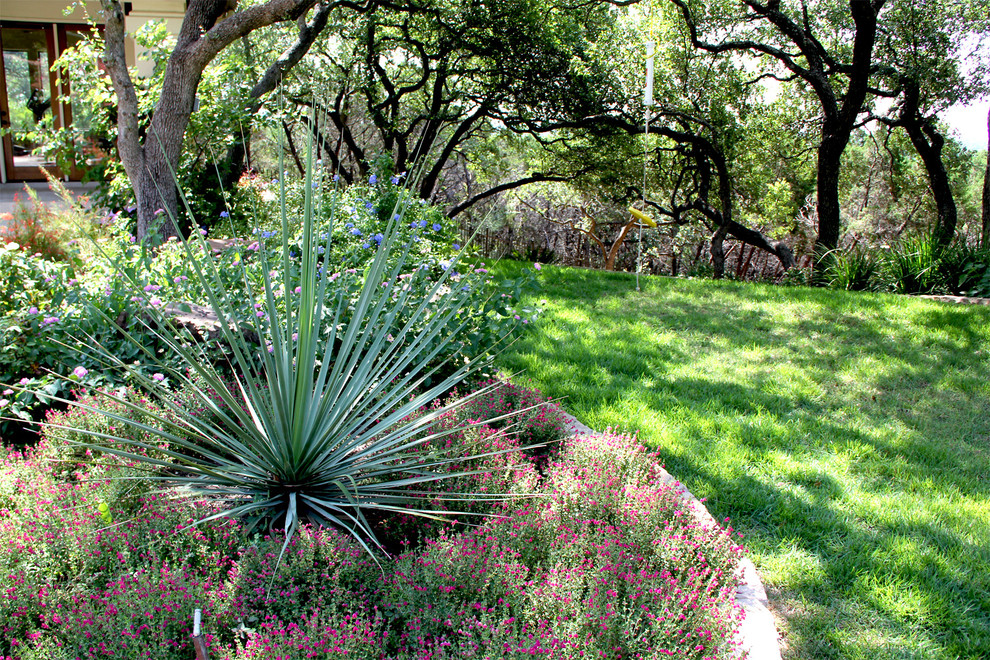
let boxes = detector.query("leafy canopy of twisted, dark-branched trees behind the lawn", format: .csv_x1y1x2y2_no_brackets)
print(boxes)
87,0,990,262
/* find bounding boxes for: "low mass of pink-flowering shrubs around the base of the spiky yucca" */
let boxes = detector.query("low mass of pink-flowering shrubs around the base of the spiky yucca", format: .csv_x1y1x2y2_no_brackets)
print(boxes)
0,388,742,660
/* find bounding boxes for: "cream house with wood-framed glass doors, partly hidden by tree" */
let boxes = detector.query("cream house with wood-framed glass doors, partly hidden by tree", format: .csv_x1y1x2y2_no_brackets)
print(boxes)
0,0,185,183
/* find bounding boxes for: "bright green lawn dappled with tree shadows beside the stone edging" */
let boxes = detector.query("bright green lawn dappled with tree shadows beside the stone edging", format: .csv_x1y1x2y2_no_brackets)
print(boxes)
500,263,990,660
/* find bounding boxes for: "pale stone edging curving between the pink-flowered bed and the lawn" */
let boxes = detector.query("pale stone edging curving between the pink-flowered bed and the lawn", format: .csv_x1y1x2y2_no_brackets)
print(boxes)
561,410,780,660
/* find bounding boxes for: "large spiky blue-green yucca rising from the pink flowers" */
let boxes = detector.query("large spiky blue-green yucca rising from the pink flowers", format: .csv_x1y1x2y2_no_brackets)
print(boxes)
13,137,536,551
